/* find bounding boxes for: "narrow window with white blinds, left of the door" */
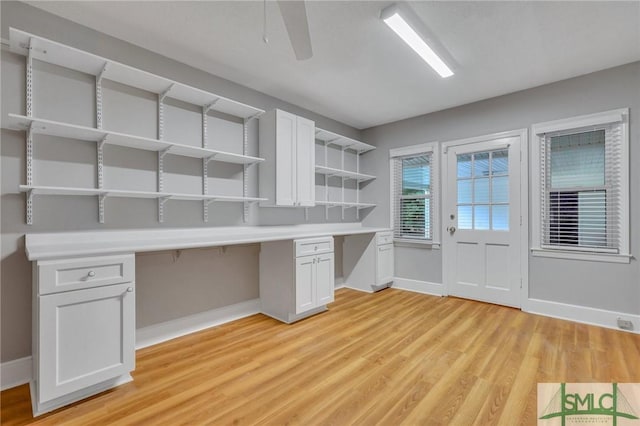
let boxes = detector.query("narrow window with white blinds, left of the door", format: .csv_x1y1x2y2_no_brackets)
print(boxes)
393,152,434,240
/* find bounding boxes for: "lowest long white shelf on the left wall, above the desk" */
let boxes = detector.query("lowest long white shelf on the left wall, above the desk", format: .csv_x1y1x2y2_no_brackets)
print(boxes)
20,185,266,203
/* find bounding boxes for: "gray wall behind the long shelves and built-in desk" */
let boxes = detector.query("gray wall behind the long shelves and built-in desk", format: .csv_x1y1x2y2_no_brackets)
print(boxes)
0,1,361,362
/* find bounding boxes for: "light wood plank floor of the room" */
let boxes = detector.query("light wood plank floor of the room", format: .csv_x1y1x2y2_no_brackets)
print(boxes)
1,289,640,425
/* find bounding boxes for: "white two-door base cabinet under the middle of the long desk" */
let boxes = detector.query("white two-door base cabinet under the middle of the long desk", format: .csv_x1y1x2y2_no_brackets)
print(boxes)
260,237,335,323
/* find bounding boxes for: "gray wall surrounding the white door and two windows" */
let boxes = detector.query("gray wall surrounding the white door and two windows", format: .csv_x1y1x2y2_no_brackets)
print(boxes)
363,62,640,314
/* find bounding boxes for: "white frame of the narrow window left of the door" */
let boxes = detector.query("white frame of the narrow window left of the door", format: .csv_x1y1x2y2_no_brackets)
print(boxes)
389,142,440,248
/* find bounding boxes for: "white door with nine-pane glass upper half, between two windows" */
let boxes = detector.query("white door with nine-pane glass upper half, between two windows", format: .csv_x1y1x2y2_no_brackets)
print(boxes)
442,136,526,307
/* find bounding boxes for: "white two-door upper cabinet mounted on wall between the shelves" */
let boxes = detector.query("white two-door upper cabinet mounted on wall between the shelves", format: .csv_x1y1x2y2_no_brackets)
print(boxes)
259,109,315,207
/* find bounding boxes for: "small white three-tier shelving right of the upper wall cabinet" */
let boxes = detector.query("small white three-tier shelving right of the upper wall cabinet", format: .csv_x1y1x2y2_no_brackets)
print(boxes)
316,129,376,219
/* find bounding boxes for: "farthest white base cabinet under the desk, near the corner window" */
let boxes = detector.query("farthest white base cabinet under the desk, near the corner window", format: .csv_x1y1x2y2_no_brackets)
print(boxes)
342,231,394,292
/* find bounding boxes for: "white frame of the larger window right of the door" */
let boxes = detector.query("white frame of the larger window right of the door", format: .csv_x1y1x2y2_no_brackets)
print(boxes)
531,108,631,263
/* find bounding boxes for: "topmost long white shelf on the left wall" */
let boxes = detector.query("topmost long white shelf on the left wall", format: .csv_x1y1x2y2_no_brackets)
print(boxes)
9,28,264,118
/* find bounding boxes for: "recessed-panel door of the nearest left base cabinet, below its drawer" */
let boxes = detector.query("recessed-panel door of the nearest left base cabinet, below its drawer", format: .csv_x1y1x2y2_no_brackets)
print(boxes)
38,283,135,403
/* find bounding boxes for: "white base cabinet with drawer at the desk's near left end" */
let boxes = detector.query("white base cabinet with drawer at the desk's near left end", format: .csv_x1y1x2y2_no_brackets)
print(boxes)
32,255,135,415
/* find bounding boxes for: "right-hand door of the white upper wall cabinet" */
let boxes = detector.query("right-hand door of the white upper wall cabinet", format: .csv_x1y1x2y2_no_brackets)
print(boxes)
296,117,316,207
